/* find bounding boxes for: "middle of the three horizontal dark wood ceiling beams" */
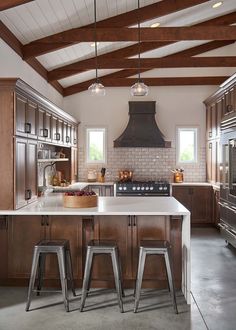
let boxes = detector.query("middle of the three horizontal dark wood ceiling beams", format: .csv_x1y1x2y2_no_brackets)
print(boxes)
57,55,236,70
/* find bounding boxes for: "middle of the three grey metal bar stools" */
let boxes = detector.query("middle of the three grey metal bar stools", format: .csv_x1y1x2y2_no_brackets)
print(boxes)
80,240,124,313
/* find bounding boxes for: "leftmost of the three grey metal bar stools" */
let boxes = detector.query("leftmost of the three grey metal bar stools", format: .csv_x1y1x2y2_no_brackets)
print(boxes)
25,240,76,312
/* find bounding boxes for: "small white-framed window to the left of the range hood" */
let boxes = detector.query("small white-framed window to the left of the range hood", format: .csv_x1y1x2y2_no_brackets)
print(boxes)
86,128,106,164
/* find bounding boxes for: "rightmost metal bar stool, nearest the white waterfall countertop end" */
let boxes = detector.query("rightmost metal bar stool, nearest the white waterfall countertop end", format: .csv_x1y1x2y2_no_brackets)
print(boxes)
134,240,178,314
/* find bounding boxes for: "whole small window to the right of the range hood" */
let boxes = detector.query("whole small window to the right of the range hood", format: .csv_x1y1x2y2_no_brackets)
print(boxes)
176,127,198,164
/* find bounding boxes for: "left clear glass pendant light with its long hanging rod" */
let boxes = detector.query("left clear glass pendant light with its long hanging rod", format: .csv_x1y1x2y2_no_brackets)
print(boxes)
88,0,106,96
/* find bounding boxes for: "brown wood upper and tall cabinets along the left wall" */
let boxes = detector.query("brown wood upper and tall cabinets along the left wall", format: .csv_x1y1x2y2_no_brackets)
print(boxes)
0,78,78,210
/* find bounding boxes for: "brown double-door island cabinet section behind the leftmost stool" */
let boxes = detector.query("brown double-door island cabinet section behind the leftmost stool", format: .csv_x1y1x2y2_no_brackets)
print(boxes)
3,216,82,285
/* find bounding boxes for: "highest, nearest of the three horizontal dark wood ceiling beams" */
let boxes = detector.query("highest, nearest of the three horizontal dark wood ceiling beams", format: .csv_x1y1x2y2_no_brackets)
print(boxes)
23,26,236,46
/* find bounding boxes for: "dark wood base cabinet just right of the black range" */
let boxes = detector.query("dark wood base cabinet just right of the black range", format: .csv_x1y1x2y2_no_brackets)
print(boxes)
172,185,213,224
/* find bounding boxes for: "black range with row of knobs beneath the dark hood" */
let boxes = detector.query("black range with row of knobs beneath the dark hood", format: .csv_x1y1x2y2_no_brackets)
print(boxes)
115,181,171,196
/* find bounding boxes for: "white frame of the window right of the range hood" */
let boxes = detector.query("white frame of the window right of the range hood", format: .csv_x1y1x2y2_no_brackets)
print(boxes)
176,126,199,165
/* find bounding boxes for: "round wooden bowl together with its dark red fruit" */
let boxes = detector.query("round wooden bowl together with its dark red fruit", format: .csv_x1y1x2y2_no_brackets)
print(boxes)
63,190,98,208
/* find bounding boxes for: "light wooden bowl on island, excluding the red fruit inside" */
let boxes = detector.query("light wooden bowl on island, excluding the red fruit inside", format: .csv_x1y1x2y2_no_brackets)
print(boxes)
63,193,98,208
